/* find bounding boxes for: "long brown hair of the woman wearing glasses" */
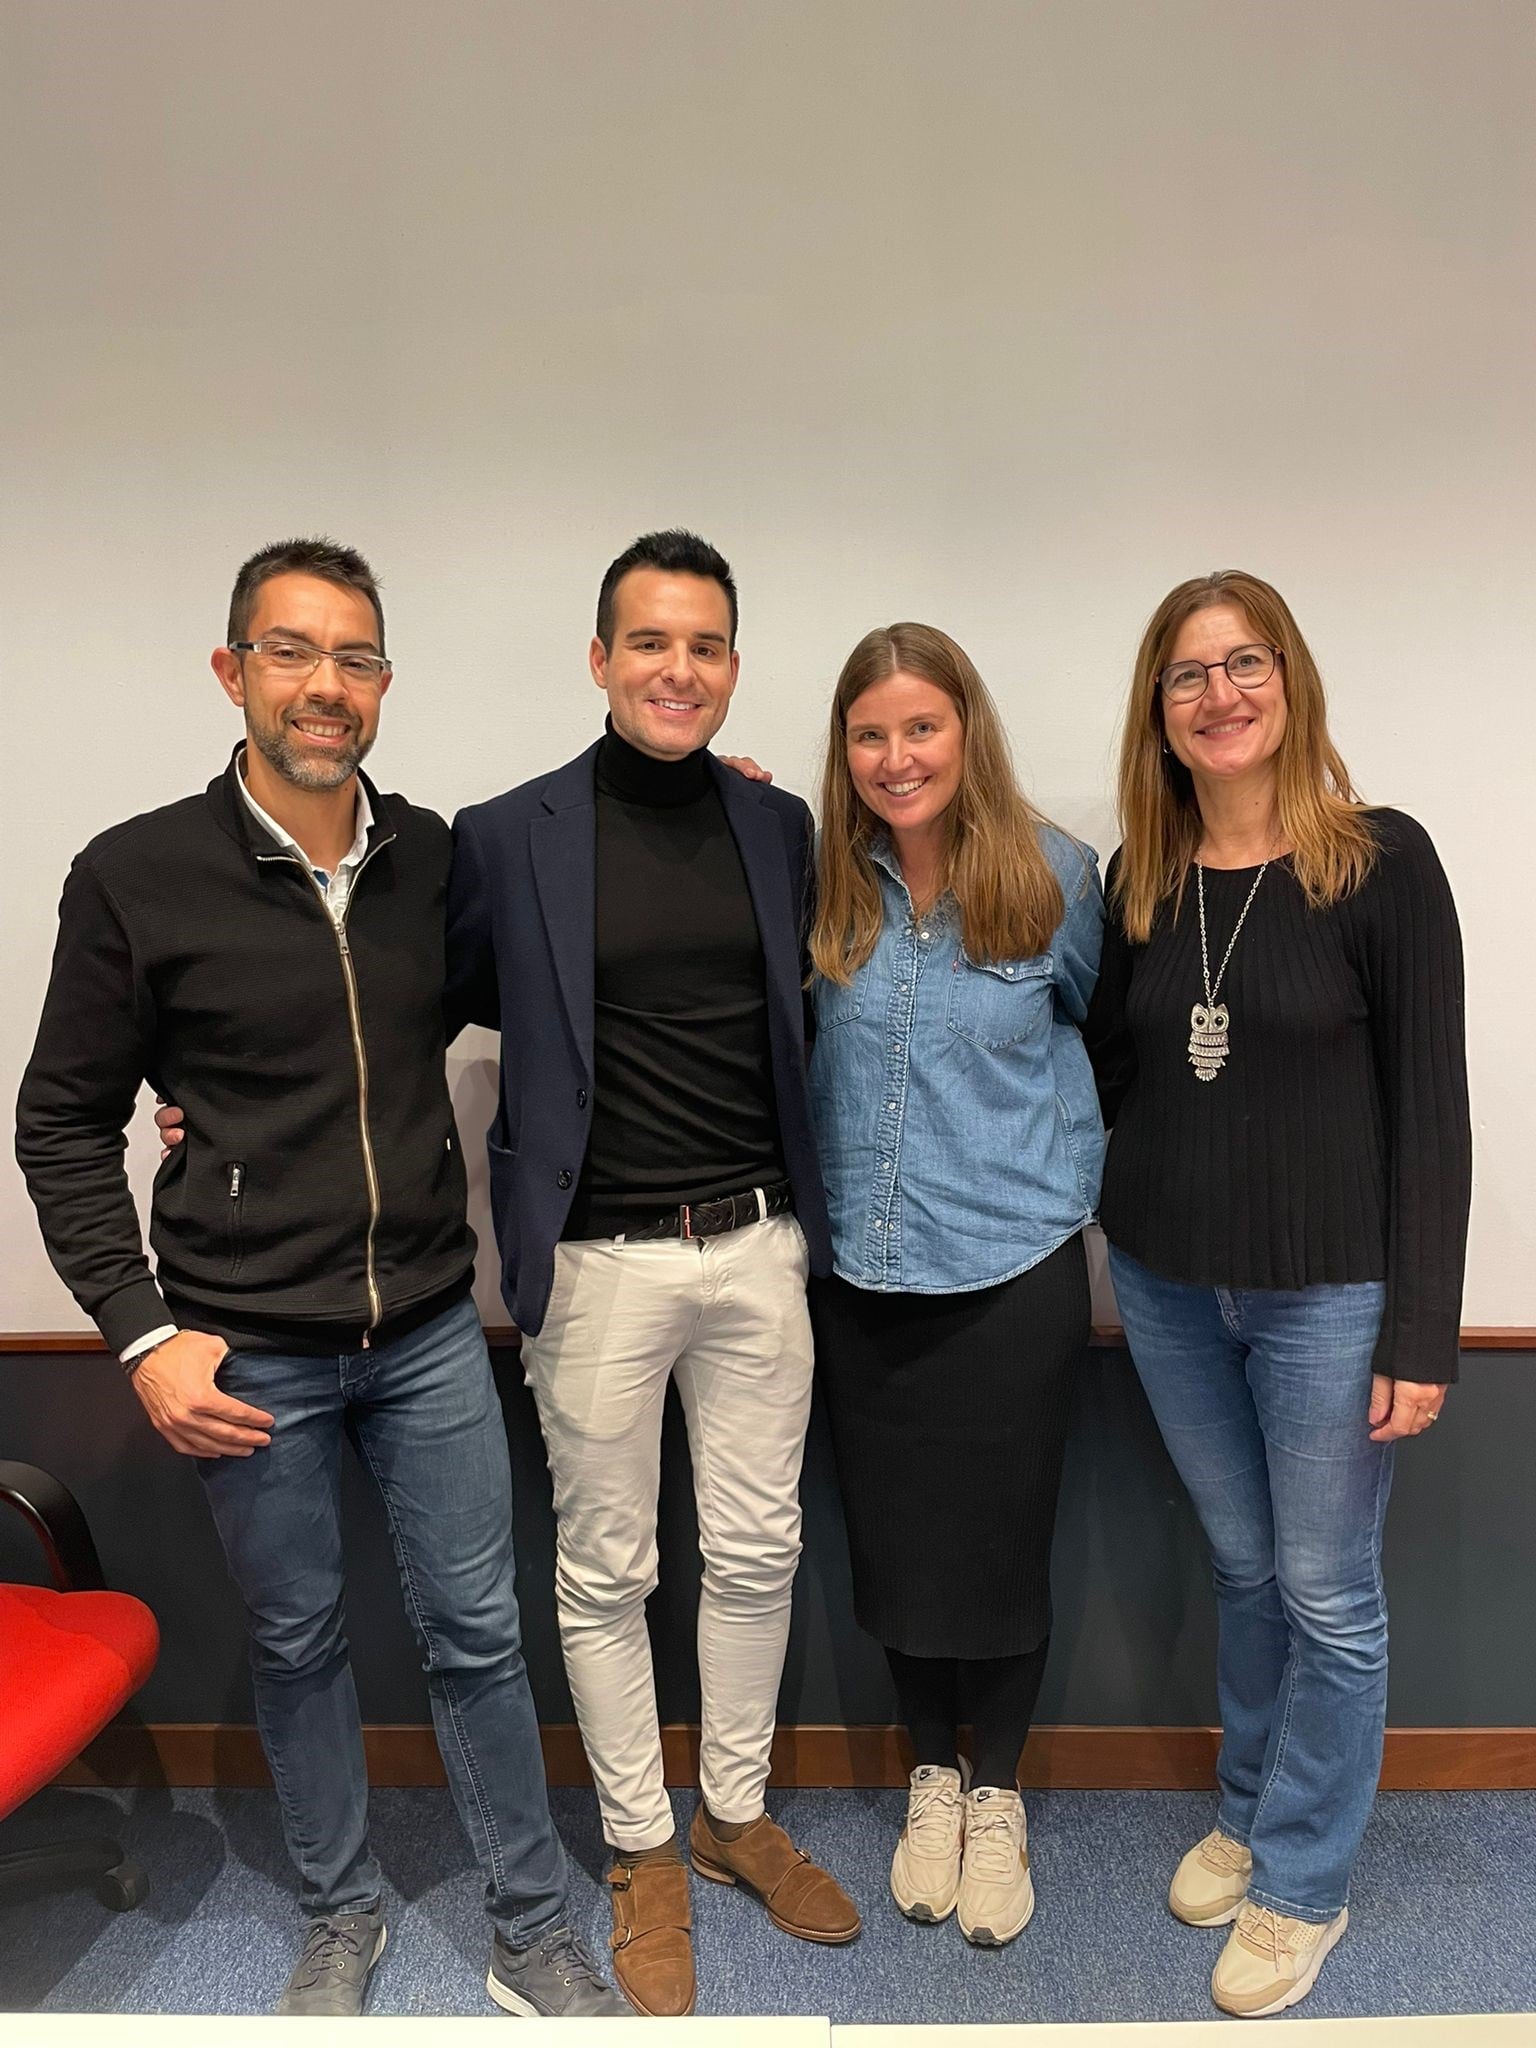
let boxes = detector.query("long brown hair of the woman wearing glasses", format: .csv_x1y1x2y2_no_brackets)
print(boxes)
1116,569,1376,940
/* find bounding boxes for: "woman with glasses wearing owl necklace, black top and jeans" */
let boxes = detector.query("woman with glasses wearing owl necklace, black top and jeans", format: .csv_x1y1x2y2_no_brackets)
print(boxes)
1083,571,1470,2017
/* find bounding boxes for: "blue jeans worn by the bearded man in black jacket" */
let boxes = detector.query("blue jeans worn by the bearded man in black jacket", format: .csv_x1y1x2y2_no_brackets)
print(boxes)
199,1300,565,1946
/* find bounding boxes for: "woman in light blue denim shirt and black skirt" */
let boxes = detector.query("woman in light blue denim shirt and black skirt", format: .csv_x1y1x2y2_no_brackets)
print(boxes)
811,625,1104,1946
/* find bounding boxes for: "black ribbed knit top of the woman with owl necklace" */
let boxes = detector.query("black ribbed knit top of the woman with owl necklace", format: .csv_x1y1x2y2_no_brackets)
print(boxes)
1083,811,1473,1380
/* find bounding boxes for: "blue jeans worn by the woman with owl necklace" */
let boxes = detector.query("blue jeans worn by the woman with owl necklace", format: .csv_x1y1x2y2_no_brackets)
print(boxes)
1110,1247,1393,1921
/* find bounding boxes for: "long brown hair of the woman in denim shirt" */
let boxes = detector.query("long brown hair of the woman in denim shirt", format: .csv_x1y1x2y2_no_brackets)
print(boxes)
811,621,1065,981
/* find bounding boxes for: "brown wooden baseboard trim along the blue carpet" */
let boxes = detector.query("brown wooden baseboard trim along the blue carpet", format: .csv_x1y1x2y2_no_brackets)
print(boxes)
59,1722,1536,1792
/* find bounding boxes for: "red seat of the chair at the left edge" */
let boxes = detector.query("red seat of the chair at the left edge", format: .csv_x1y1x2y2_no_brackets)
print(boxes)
0,1585,160,1817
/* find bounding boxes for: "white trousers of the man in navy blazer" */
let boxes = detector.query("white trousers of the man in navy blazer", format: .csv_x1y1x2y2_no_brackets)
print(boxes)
522,1217,811,1851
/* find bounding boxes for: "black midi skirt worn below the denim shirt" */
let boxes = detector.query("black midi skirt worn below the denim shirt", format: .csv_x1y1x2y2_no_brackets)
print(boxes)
811,1235,1090,1657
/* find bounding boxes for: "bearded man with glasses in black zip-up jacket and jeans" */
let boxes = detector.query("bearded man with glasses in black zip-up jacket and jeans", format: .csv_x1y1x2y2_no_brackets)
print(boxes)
16,541,625,2015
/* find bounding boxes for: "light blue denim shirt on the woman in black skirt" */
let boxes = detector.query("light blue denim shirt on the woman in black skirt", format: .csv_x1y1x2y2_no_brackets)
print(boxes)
811,827,1104,1294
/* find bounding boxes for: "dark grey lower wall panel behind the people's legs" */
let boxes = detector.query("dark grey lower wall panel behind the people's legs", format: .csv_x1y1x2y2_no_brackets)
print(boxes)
0,1352,1536,1726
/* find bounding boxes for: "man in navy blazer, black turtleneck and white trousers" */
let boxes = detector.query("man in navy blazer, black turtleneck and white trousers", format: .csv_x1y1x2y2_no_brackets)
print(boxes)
449,530,860,2013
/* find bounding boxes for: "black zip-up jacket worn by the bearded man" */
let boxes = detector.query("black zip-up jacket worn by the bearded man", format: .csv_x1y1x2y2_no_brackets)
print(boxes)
16,756,475,1352
